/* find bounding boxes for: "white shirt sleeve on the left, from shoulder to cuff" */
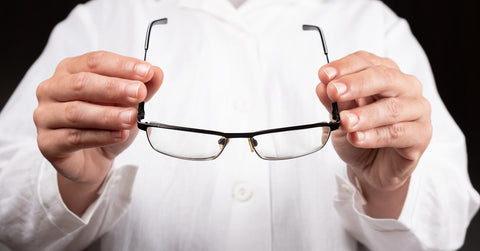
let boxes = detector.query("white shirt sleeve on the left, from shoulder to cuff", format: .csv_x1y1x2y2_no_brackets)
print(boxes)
0,1,137,250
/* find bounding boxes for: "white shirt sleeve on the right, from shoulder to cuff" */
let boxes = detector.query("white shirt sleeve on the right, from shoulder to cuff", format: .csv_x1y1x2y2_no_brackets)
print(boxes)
334,2,480,250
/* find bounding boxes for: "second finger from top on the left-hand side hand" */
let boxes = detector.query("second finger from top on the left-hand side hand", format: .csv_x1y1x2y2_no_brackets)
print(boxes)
37,72,147,105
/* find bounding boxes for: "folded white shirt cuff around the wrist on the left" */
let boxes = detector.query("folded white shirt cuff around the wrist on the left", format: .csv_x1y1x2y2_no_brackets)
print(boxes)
37,161,138,234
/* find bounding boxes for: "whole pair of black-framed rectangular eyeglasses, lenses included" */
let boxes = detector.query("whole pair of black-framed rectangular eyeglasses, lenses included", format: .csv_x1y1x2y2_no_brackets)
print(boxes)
137,18,340,160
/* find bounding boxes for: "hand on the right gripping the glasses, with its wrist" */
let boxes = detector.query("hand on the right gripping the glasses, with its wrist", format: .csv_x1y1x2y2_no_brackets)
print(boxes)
317,52,432,218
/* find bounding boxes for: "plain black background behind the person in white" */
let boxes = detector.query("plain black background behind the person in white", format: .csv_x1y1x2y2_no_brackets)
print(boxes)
0,0,480,250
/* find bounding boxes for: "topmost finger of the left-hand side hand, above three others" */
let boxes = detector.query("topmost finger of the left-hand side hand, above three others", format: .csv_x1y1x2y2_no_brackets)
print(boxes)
57,51,154,82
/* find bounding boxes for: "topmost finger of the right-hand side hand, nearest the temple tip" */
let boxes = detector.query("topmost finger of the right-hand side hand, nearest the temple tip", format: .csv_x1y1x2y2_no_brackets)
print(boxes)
318,51,398,84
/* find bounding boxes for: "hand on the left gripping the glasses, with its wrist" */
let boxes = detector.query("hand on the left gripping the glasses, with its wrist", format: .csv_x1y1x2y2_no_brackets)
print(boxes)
34,51,163,214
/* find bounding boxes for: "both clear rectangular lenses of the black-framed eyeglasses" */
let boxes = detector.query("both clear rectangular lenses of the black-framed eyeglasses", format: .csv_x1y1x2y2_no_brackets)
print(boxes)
147,126,330,160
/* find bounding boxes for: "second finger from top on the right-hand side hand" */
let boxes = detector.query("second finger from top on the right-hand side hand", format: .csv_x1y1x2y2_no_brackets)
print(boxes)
327,66,422,102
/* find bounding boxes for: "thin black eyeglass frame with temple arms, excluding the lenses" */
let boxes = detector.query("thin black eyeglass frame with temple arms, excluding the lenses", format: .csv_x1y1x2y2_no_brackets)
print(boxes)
137,18,340,160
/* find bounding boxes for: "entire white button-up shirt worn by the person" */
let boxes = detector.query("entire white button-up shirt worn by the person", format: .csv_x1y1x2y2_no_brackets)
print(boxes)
0,0,479,250
